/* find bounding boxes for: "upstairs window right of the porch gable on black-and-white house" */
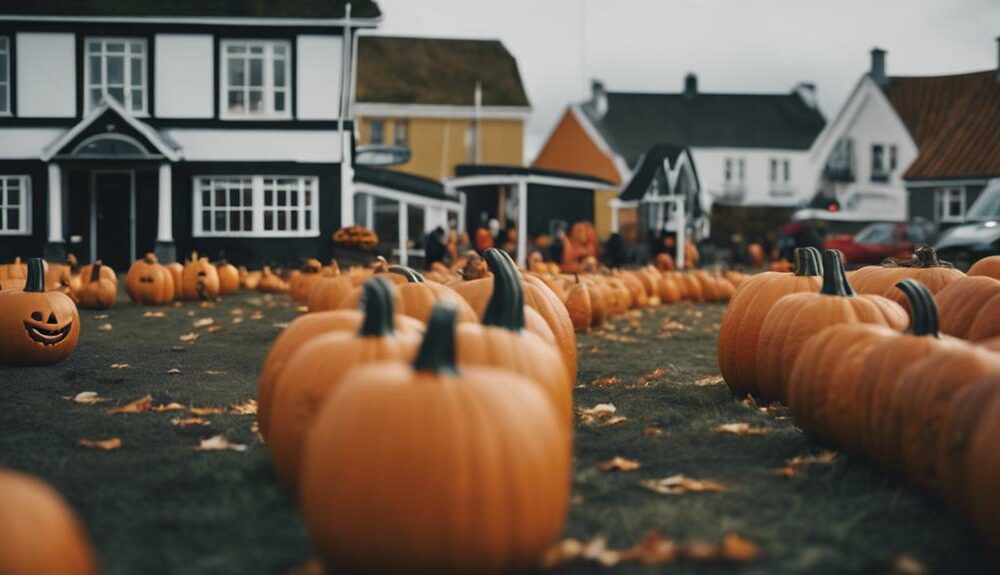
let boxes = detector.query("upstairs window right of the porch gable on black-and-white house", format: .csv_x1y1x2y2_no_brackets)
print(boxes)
220,40,292,119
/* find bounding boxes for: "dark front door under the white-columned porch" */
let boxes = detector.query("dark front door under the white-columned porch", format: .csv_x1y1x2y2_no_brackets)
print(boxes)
91,172,134,275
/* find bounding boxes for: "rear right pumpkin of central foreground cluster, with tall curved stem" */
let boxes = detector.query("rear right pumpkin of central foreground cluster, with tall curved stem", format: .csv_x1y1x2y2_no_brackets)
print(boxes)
455,250,576,433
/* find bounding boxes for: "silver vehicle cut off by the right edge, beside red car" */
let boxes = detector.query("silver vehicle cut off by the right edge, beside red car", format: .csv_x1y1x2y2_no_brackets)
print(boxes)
934,179,1000,270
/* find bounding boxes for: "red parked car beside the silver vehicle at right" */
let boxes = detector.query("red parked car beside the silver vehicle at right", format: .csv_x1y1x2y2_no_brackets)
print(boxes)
823,220,934,266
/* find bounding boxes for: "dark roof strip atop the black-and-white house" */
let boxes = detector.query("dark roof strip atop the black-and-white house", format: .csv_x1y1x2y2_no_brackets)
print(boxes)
0,0,381,18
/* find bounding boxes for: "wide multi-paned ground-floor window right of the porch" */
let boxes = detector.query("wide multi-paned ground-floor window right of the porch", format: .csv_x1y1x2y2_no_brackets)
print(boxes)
194,176,319,237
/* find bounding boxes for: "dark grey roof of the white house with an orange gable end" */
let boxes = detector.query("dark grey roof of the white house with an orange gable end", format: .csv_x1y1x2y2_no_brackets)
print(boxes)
581,92,826,166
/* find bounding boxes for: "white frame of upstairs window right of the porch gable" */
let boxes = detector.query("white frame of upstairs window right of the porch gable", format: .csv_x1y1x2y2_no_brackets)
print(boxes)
219,39,295,120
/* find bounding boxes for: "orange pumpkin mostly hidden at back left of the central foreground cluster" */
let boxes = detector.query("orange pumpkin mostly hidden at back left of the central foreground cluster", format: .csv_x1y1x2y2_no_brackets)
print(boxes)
257,282,424,439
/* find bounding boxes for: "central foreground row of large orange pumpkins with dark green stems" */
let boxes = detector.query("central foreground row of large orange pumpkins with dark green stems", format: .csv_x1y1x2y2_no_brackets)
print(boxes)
257,248,577,573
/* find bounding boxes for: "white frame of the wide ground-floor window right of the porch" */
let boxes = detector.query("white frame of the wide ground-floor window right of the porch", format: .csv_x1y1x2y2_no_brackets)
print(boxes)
191,174,320,238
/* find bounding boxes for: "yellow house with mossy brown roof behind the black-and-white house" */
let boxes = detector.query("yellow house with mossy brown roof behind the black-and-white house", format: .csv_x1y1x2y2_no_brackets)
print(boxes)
353,36,531,181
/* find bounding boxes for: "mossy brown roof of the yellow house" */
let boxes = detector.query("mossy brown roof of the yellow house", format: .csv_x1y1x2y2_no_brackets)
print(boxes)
357,36,529,106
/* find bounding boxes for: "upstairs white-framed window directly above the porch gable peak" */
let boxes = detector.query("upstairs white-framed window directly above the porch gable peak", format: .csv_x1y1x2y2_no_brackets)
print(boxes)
84,38,147,115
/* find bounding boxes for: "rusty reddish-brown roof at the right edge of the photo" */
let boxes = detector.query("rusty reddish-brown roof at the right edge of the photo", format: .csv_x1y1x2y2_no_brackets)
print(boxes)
883,70,1000,180
